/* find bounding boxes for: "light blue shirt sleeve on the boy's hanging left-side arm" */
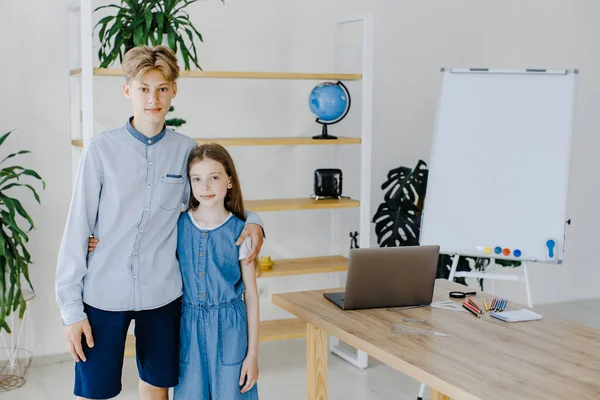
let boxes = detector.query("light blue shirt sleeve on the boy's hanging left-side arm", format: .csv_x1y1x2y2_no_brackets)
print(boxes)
55,140,102,325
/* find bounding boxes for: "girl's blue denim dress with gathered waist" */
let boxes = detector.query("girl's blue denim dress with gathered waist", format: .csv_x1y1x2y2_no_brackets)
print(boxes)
174,213,258,400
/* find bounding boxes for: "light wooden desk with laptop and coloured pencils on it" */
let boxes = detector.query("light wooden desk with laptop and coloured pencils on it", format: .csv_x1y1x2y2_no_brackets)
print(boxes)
273,280,600,400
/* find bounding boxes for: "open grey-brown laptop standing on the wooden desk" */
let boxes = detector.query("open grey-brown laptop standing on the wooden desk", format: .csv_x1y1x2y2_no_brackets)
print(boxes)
323,245,440,310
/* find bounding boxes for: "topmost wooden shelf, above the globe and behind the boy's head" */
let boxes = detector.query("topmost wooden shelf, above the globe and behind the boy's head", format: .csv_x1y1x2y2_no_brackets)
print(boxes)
71,68,362,81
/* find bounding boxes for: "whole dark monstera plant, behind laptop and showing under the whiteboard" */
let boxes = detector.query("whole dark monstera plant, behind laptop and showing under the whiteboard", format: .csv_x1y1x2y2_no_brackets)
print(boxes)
373,160,521,290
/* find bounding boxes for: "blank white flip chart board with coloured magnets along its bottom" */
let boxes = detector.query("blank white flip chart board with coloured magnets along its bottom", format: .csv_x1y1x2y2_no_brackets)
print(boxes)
420,69,578,263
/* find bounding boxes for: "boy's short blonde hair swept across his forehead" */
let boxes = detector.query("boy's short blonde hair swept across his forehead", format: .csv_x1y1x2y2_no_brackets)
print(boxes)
121,46,179,82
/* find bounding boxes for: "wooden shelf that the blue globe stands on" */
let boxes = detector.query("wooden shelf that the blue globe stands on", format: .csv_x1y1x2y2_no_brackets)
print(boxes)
71,136,361,147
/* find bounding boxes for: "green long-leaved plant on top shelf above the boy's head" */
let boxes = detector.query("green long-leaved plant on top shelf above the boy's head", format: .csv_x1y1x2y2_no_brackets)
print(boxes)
94,0,224,70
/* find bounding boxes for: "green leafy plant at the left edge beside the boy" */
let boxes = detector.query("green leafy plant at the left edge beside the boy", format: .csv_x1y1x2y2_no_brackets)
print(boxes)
0,131,46,333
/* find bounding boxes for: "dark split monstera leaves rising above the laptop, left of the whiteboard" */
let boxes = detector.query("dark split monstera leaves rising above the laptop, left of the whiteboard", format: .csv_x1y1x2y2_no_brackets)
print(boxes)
373,160,429,247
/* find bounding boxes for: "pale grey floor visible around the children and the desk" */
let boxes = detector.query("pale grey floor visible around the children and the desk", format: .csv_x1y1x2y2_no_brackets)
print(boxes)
0,299,600,400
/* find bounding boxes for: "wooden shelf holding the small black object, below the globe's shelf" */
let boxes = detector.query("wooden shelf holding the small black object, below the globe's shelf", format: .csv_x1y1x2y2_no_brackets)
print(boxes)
244,197,360,212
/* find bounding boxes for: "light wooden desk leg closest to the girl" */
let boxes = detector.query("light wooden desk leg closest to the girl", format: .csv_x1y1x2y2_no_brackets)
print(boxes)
306,323,327,400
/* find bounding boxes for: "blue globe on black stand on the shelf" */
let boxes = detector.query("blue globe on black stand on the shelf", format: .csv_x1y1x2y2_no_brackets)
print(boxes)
308,82,350,139
